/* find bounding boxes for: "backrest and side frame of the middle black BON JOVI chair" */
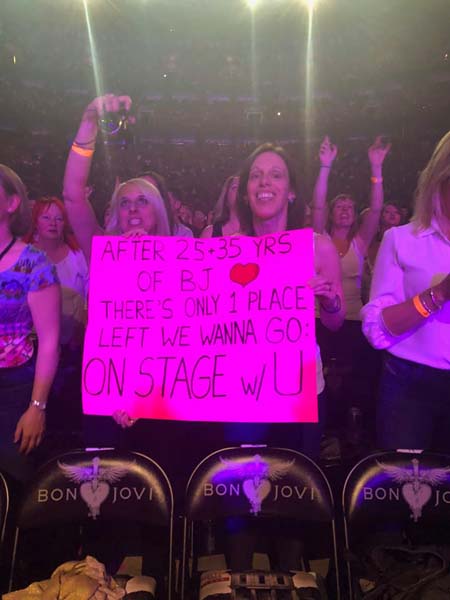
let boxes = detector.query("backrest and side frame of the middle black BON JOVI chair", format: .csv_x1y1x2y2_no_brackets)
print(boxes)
182,447,338,595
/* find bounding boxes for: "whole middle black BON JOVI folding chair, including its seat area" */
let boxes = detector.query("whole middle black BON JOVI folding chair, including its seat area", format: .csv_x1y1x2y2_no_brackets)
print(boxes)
181,446,340,600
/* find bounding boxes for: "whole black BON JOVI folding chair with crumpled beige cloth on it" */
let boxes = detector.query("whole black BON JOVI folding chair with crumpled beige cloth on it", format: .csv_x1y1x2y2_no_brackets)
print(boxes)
9,450,173,599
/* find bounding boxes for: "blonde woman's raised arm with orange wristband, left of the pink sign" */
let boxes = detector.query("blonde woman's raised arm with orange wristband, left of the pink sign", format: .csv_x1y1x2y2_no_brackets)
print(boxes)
63,94,131,261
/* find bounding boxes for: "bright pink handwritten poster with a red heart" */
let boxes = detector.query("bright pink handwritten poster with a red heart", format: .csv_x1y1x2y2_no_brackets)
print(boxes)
82,229,317,422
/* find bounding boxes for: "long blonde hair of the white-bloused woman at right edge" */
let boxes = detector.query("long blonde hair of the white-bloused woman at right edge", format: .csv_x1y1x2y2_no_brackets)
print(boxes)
412,131,450,230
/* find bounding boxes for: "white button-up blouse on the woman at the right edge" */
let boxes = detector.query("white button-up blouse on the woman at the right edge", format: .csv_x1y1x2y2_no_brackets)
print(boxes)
361,222,450,369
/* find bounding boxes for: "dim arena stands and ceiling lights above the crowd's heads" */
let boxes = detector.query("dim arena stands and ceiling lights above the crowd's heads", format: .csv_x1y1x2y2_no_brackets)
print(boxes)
0,0,450,212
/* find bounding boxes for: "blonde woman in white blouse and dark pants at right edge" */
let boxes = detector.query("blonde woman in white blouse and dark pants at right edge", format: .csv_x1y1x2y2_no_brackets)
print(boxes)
362,132,450,451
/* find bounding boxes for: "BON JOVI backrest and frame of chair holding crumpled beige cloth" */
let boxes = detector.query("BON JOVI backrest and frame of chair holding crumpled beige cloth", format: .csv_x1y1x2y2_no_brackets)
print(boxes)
10,449,173,595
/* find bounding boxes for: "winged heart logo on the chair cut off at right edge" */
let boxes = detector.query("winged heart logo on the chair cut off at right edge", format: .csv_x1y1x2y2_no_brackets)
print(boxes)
377,458,450,523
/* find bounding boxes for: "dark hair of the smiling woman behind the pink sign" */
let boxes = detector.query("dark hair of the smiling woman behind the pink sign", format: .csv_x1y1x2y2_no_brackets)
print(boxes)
236,143,305,235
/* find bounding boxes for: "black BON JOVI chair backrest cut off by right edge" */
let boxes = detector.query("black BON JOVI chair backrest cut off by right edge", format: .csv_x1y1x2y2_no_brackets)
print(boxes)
342,451,450,587
